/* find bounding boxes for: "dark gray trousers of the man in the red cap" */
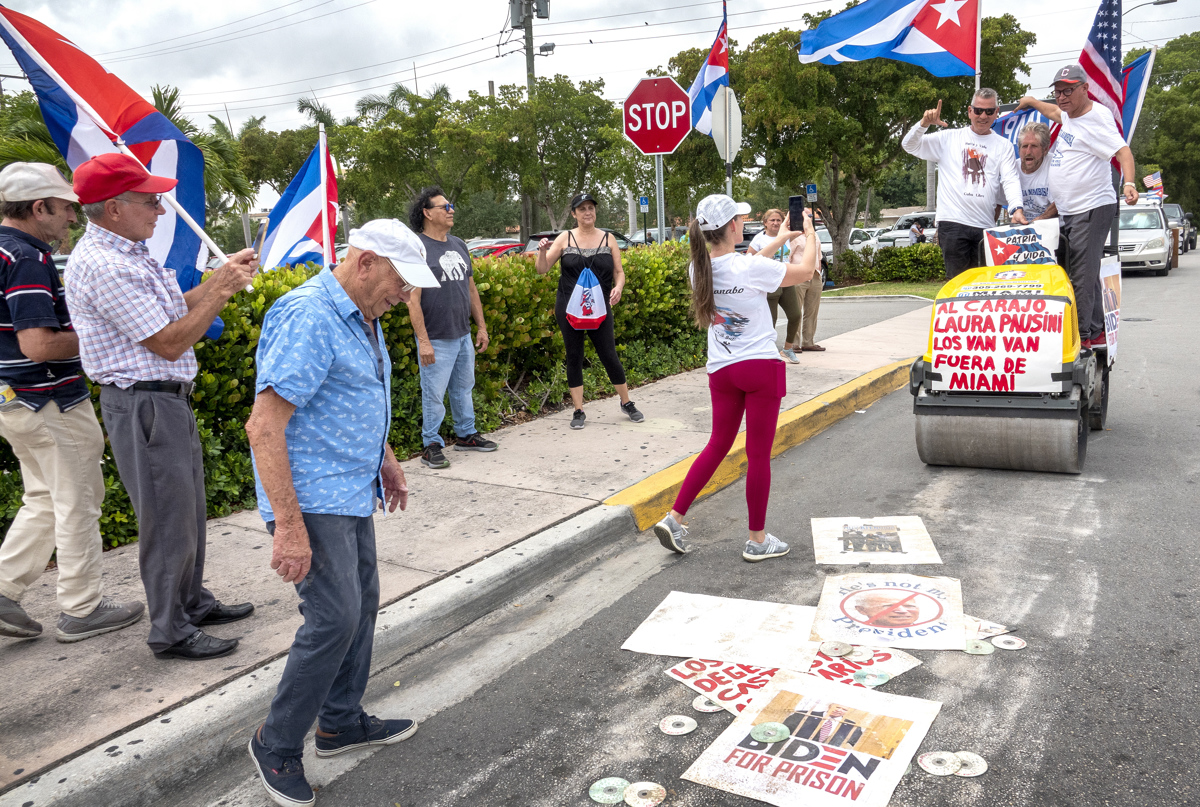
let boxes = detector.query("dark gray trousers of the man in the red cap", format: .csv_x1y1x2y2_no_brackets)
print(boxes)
100,384,216,651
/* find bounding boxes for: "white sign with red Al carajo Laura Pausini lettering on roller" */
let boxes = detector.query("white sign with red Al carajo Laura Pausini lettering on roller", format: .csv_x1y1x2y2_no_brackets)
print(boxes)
931,297,1067,393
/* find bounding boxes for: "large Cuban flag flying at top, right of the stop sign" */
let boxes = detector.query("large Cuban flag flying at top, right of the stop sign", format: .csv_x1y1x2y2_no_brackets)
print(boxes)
799,0,979,78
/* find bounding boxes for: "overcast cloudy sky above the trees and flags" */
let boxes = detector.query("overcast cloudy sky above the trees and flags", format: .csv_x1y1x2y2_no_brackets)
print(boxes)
0,0,1200,128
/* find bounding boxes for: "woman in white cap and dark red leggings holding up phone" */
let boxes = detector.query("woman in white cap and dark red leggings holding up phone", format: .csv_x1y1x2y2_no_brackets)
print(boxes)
654,193,821,562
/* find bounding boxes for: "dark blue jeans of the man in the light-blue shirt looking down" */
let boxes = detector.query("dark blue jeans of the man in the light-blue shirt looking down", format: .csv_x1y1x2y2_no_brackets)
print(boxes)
263,513,379,757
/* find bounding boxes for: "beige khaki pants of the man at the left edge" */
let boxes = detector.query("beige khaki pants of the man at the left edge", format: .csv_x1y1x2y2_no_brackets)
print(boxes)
0,401,104,616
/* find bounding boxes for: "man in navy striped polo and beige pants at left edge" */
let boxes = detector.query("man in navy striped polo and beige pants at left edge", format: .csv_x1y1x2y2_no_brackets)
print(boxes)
0,162,145,641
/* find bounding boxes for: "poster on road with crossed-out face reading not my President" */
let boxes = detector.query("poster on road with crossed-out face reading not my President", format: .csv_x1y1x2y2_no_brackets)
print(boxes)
810,572,966,650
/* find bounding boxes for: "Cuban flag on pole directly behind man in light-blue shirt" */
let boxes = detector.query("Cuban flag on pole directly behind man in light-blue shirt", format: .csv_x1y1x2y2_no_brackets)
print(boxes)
258,126,337,270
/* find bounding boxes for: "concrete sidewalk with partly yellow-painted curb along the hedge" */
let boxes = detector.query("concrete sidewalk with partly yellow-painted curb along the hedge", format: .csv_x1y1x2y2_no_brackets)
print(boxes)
0,305,929,805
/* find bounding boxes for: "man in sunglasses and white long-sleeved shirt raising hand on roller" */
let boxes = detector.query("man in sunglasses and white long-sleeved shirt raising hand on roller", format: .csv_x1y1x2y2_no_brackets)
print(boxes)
902,88,1028,280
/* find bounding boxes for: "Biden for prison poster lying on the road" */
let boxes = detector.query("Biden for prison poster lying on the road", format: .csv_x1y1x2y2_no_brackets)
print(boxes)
683,671,942,807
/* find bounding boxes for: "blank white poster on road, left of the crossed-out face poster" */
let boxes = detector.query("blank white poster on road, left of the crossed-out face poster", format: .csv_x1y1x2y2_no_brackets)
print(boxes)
620,591,817,673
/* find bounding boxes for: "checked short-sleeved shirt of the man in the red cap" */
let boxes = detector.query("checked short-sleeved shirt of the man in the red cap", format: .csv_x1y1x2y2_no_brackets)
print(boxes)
66,221,198,389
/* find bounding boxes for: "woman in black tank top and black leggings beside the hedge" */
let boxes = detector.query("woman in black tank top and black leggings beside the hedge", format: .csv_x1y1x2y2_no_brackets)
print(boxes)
536,193,644,429
